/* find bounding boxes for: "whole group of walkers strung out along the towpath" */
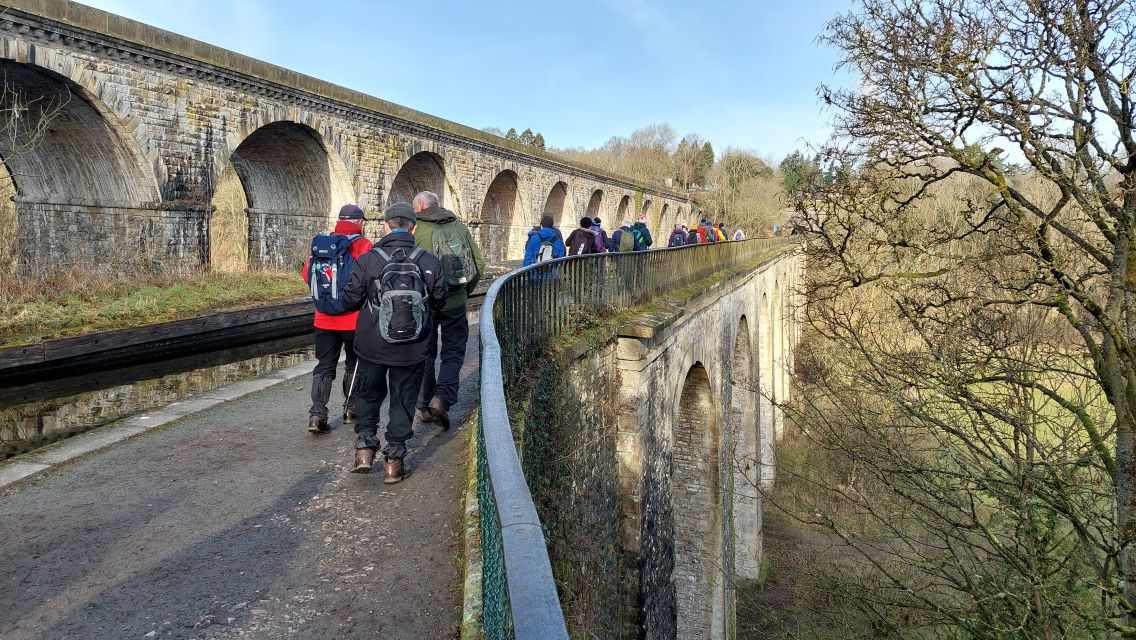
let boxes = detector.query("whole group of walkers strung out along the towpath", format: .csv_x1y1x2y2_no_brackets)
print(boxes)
303,197,745,483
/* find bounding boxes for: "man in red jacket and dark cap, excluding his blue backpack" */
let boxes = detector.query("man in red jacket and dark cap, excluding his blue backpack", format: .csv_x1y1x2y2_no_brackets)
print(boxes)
303,205,371,433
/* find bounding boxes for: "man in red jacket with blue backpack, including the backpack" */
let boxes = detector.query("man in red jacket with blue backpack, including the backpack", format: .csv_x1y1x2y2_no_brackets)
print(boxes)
303,205,371,434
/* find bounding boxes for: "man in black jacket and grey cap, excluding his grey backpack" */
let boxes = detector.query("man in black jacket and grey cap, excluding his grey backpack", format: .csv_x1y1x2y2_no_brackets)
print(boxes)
343,202,449,484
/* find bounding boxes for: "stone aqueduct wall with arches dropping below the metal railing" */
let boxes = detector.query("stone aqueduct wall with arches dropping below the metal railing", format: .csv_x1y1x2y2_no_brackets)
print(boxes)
497,244,804,640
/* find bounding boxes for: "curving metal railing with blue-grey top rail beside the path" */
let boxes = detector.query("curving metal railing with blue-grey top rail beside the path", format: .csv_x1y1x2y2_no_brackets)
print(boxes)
477,238,794,640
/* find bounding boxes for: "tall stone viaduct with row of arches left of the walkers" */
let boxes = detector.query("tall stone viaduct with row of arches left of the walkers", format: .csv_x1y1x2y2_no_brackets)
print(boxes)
0,0,691,271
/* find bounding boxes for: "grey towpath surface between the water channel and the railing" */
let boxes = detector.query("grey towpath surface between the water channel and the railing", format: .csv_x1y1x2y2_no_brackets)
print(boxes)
0,325,477,640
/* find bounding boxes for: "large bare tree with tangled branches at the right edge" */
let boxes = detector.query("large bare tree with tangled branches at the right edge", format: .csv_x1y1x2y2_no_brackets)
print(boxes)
790,0,1136,638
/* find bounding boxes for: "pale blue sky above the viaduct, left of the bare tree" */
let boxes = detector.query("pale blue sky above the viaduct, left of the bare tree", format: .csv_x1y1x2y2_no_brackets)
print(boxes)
86,0,851,160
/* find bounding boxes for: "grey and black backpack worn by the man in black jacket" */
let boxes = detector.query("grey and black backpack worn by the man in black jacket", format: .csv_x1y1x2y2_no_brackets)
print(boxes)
367,247,429,344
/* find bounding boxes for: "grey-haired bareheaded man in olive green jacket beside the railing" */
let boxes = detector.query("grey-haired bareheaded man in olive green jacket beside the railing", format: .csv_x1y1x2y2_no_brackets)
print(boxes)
414,191,485,429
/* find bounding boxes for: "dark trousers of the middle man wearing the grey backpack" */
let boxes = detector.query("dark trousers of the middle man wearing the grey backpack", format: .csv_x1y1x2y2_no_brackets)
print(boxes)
356,358,426,458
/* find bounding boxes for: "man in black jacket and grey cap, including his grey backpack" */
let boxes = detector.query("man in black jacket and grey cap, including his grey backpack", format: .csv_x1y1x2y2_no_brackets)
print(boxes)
344,202,449,484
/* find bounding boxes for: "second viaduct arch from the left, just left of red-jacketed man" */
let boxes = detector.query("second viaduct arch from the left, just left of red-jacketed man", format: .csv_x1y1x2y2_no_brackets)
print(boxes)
209,122,353,269
